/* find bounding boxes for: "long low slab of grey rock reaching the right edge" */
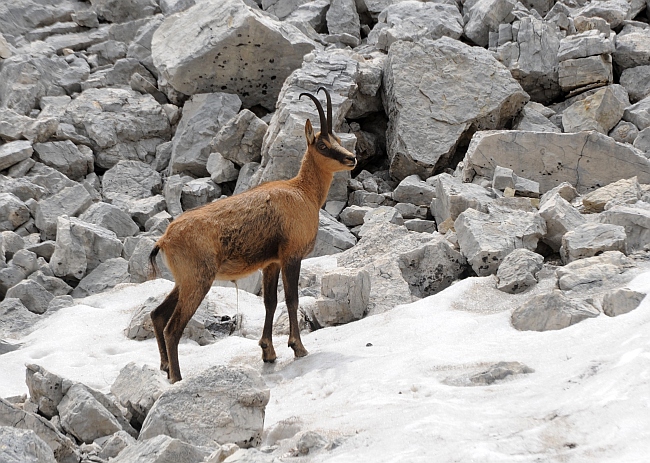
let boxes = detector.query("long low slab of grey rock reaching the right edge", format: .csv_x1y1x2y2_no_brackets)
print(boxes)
463,131,650,193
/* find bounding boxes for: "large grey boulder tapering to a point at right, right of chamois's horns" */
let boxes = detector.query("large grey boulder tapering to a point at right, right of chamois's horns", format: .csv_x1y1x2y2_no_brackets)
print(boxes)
383,37,528,179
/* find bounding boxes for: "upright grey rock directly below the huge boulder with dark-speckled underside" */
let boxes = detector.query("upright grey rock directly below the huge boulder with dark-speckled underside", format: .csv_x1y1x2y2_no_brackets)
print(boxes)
170,92,241,177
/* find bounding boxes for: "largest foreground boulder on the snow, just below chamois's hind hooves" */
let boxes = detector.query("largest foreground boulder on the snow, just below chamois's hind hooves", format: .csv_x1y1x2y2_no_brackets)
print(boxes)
138,366,270,447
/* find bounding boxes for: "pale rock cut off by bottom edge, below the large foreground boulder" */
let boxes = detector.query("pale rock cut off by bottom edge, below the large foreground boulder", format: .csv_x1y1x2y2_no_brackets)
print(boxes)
111,435,215,463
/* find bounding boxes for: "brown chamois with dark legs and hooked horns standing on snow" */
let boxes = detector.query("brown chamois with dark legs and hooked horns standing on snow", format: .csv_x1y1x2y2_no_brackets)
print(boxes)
149,87,357,383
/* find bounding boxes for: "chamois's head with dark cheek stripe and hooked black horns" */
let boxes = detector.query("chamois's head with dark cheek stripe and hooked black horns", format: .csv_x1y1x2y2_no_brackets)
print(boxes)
299,87,357,172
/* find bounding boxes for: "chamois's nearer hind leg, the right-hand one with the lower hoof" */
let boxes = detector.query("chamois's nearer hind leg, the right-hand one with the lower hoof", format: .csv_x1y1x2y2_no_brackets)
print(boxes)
164,280,212,383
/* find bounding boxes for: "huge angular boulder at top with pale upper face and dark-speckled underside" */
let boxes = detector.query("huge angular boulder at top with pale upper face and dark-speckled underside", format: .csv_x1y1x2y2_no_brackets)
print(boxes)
151,0,316,109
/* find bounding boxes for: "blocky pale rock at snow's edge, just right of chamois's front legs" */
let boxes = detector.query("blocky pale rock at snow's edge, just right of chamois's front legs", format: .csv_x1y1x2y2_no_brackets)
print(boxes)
311,268,371,326
